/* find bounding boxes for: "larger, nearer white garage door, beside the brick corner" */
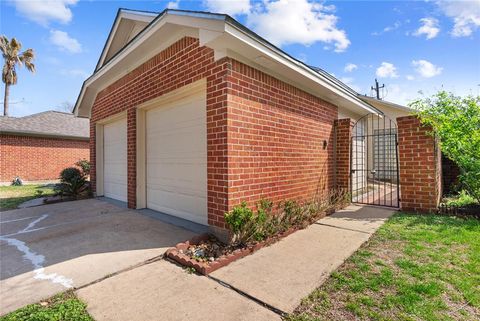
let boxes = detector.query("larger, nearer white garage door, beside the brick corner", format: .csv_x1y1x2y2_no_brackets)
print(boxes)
146,93,207,225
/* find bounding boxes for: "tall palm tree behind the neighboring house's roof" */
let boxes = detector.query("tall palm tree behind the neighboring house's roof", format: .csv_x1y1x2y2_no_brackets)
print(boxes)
0,36,35,116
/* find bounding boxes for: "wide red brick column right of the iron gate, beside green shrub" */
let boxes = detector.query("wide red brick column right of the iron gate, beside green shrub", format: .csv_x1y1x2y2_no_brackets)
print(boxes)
397,116,442,212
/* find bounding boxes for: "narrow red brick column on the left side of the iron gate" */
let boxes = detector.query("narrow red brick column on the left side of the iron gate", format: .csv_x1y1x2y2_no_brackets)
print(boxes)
335,118,355,190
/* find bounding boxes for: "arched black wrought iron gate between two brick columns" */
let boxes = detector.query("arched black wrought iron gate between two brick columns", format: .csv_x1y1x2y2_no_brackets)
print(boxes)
350,114,400,207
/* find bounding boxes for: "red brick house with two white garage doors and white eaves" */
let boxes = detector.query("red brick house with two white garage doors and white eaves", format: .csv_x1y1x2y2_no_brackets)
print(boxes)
74,9,437,233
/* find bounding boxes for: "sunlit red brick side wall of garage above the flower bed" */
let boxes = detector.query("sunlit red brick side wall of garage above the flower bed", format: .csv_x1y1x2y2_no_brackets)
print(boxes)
227,60,338,215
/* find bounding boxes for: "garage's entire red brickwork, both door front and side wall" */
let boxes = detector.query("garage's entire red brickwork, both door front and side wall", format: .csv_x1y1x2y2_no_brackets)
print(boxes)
90,37,337,228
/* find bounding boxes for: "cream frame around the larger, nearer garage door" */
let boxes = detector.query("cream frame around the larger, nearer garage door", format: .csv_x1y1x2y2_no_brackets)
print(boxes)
136,79,208,225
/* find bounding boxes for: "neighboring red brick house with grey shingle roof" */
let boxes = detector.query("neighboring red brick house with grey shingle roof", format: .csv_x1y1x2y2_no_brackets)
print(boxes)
0,111,90,183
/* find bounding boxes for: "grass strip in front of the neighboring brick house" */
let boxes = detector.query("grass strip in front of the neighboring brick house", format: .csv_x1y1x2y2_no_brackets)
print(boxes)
0,185,54,211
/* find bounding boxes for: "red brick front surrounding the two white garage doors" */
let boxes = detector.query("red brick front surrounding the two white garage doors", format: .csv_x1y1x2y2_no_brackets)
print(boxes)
90,37,229,216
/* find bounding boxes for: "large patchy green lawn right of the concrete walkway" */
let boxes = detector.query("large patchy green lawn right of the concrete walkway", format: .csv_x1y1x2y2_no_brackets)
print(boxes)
287,214,480,321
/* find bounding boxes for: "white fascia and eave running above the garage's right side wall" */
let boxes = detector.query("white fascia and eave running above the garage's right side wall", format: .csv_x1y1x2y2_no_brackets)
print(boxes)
225,22,378,113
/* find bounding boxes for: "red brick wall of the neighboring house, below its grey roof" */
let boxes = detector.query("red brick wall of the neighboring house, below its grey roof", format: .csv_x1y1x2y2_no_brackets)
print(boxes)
0,135,89,182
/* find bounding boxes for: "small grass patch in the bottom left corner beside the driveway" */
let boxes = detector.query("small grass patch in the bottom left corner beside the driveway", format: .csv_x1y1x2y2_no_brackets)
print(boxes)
0,291,93,321
